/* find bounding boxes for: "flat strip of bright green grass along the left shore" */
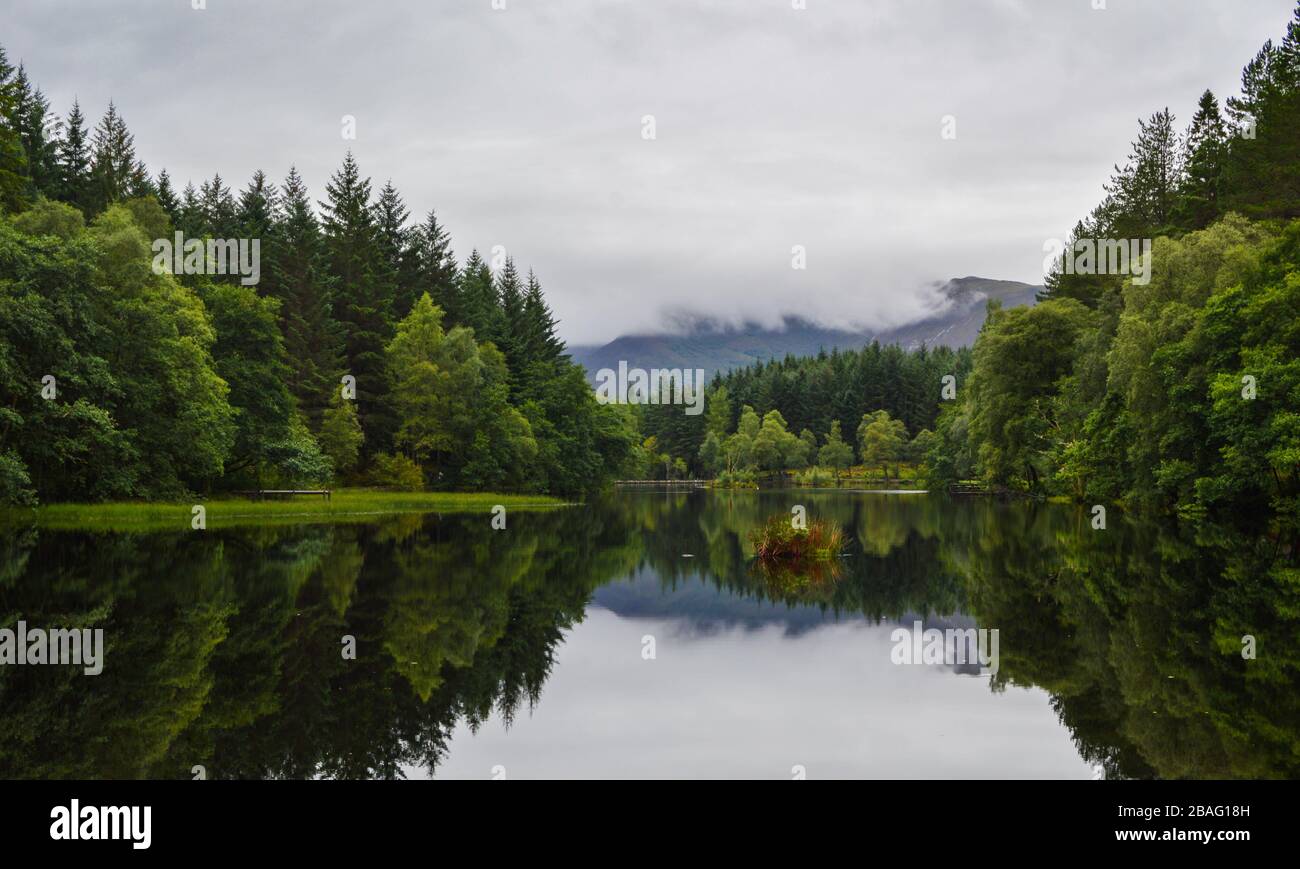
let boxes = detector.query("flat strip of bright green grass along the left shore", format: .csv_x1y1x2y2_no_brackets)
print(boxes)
0,489,567,531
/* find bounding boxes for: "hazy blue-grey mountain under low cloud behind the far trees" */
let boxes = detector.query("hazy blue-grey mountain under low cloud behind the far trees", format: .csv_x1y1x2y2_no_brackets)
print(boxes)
568,277,1043,377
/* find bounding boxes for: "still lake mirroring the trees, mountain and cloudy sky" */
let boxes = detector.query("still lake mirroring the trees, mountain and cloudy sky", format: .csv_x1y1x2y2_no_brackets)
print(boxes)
0,489,1300,779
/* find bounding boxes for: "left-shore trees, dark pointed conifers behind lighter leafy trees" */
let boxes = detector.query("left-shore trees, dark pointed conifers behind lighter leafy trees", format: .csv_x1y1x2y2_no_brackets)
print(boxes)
0,48,640,502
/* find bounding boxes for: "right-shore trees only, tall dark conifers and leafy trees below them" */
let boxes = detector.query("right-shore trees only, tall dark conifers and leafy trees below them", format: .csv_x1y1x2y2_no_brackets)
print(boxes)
930,7,1300,520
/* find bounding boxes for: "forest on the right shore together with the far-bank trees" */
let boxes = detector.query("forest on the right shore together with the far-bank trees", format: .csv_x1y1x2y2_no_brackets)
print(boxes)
642,7,1300,518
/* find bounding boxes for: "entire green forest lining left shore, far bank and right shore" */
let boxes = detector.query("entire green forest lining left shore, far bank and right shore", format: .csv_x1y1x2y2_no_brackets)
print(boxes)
0,7,1300,516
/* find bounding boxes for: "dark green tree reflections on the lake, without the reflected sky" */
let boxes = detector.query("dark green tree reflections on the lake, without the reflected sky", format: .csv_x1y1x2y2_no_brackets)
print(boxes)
0,490,1300,778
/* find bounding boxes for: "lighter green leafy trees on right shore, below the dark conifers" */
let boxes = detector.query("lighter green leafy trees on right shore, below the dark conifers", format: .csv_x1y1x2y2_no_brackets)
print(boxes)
946,215,1300,523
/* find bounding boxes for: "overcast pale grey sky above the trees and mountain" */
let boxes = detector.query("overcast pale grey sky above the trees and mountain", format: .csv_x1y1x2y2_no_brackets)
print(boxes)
0,0,1295,343
